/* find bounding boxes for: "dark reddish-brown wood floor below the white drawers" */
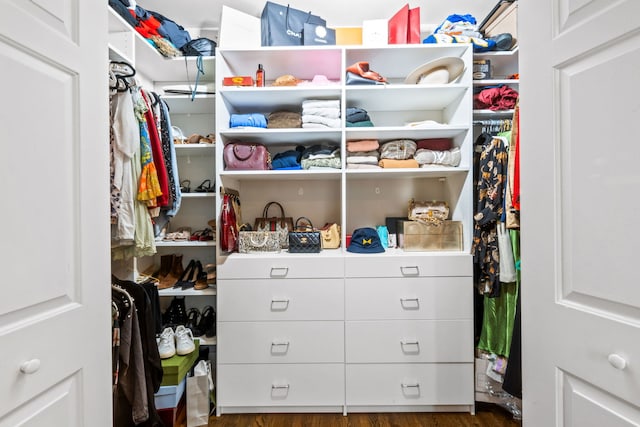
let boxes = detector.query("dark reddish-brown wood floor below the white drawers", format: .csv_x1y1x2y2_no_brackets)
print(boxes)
200,403,521,427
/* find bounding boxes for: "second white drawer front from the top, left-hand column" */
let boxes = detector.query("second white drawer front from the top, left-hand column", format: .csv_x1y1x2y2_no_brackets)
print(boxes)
217,279,344,321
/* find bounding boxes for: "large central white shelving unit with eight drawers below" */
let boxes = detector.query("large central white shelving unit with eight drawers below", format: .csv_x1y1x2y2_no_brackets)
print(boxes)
216,45,474,414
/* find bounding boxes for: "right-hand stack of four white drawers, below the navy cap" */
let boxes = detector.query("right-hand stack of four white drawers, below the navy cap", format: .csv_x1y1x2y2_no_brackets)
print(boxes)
345,255,474,412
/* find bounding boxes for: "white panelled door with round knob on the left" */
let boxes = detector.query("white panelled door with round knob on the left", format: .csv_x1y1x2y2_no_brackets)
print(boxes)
0,0,111,427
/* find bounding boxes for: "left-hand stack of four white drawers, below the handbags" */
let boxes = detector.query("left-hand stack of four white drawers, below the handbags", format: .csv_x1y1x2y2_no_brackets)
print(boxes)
217,255,345,414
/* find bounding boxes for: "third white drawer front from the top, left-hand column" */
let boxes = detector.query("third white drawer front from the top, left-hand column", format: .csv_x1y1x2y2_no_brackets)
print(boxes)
217,321,344,363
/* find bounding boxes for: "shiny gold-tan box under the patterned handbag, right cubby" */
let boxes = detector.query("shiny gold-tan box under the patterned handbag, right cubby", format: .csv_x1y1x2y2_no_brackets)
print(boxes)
403,221,462,251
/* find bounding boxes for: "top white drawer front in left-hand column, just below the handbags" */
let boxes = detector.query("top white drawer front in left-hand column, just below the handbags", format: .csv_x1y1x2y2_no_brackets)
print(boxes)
217,253,344,279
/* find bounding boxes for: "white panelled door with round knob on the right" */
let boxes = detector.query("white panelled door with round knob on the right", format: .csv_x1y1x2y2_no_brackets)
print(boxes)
518,0,640,427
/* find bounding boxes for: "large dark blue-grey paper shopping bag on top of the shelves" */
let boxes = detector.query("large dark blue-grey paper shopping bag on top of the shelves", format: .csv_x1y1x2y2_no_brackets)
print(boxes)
260,1,327,46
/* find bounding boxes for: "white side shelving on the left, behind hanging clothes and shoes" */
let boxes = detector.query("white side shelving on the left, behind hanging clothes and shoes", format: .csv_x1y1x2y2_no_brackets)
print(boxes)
108,4,217,345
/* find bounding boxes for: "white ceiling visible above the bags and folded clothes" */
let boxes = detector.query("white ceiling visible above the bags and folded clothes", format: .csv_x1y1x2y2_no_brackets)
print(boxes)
138,0,498,35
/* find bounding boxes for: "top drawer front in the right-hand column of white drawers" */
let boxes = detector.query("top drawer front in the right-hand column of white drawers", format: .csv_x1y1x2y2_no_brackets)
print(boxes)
345,254,473,277
